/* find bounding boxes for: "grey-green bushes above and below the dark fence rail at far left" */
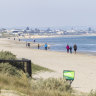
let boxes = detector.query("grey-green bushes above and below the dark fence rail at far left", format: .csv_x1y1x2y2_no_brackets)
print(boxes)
0,51,20,76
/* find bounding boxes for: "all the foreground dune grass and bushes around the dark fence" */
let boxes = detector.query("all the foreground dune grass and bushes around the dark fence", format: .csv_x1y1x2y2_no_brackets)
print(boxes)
0,51,96,96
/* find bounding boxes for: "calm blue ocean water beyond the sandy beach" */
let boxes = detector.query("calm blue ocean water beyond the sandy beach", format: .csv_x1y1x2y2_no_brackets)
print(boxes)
23,36,96,53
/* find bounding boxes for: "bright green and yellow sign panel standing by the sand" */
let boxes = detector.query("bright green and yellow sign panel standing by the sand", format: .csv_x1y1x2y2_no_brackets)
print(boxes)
63,70,75,80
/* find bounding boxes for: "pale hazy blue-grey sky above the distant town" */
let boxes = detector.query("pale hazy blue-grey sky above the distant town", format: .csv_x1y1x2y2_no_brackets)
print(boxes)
0,0,96,27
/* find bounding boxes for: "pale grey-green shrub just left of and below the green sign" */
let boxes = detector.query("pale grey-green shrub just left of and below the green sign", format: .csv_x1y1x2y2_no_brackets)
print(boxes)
32,78,72,93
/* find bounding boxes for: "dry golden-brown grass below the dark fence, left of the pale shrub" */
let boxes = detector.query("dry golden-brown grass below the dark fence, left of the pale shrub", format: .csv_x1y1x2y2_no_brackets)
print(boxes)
0,72,30,94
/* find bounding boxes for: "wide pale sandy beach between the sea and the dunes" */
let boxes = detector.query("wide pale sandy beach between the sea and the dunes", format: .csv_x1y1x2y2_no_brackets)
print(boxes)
0,38,96,92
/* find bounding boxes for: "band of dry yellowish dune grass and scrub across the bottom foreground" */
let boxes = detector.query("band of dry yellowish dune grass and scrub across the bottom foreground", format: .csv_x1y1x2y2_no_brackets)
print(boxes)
0,73,74,96
